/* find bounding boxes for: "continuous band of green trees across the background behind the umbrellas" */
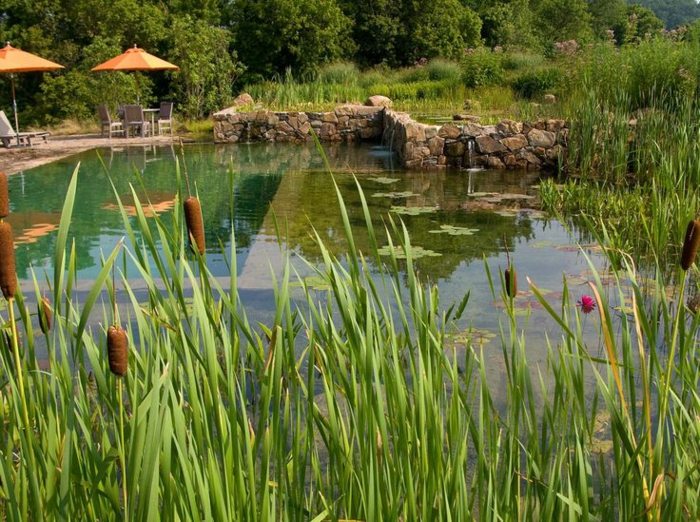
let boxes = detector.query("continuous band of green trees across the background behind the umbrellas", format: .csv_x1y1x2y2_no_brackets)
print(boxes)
0,0,700,123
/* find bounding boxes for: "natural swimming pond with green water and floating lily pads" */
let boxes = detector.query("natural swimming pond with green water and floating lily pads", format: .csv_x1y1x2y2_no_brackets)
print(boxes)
8,140,602,380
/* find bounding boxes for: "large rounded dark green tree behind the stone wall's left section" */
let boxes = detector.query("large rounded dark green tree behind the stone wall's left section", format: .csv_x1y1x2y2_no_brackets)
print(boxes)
233,0,354,78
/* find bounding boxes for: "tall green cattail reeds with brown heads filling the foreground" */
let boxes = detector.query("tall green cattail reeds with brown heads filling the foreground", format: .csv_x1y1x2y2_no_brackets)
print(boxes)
0,142,700,520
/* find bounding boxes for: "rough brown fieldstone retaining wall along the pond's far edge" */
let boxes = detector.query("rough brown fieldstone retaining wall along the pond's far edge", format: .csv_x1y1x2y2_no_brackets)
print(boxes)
214,105,569,170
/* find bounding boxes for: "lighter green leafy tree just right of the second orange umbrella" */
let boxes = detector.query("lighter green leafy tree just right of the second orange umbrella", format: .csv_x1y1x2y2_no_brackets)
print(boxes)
169,15,242,118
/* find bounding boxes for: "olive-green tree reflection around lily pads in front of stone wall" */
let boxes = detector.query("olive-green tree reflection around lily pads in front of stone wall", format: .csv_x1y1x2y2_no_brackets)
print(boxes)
264,171,534,279
